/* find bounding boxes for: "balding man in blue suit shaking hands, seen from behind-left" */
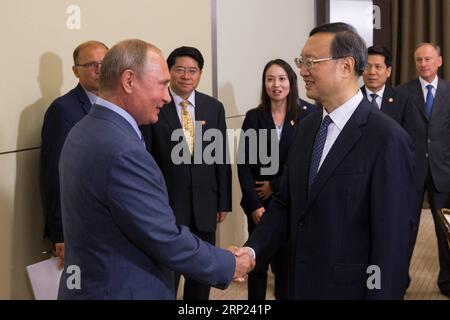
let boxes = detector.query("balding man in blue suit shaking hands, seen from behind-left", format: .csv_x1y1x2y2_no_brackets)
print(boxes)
59,40,253,299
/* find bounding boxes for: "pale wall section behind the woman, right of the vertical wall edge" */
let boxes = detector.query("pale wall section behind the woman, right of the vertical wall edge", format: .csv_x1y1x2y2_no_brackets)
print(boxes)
217,0,314,247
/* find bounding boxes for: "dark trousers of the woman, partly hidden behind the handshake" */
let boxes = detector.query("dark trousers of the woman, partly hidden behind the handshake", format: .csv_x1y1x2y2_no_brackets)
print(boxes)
247,215,289,300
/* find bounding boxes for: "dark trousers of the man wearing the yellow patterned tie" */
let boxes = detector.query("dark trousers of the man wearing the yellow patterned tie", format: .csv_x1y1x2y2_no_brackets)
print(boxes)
175,223,216,300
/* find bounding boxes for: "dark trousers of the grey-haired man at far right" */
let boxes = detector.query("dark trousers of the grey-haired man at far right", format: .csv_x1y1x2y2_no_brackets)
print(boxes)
411,169,450,292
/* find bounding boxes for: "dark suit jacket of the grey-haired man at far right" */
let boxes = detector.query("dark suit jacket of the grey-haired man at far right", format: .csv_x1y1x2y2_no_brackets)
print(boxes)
398,79,450,193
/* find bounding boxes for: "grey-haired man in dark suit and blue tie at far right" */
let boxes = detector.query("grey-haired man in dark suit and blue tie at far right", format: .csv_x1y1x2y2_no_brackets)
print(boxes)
399,43,450,296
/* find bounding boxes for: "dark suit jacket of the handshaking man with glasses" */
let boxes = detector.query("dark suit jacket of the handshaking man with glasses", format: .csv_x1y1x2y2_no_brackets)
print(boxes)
245,99,415,299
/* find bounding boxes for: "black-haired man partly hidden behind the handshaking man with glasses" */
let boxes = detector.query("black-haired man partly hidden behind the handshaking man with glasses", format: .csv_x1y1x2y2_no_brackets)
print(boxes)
361,46,414,136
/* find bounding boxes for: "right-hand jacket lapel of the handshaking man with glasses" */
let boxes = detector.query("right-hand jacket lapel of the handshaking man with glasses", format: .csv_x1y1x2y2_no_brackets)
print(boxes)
303,99,372,214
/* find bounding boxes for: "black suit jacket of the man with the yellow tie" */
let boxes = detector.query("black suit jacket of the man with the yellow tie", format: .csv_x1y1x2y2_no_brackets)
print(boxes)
141,91,231,232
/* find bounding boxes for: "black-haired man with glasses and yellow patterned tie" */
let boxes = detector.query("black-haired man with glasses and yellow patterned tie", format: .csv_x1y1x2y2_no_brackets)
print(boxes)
141,46,231,300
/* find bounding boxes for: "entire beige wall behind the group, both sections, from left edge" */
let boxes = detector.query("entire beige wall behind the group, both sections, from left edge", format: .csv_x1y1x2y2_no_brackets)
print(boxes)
0,0,314,299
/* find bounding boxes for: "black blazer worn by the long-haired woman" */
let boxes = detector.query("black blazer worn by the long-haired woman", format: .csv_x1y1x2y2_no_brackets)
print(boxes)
237,100,317,215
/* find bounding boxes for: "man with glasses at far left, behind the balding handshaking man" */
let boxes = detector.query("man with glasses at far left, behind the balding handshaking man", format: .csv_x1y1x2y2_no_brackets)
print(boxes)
40,41,108,267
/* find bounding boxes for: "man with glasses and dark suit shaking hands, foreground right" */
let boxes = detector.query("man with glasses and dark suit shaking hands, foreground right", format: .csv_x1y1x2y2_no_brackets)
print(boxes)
236,23,414,299
